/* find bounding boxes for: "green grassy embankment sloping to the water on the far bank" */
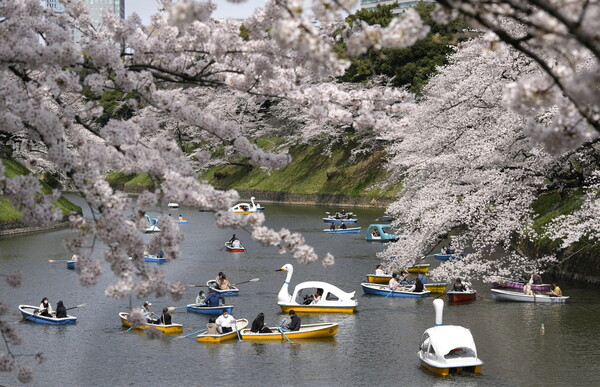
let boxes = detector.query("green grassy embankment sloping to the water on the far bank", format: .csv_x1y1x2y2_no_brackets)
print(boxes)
106,138,401,202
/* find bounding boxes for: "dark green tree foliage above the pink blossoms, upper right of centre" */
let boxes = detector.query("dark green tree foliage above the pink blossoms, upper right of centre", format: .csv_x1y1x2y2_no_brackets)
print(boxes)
339,2,466,94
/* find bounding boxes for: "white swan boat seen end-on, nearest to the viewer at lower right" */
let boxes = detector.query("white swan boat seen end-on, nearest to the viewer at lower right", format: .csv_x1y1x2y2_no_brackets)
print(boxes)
417,299,483,376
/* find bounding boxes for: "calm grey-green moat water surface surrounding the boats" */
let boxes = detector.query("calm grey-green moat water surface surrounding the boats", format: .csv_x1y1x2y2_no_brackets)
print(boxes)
0,199,600,386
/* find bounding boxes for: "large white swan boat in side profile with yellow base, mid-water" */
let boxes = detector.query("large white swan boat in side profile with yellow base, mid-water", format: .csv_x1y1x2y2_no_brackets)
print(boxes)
277,263,358,313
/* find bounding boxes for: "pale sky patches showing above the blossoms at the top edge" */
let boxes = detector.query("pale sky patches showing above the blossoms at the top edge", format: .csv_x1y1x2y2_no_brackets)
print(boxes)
125,0,266,23
